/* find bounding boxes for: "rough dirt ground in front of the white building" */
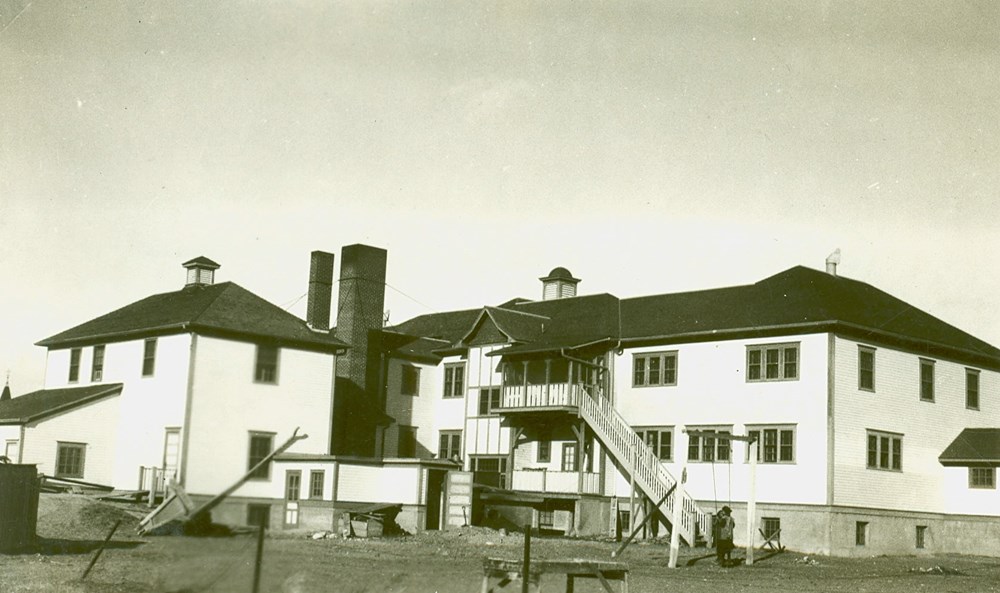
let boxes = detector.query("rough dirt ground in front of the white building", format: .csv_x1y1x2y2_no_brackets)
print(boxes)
0,494,1000,593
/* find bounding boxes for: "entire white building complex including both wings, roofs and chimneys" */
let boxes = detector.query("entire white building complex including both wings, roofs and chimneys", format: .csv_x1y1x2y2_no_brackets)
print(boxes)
0,245,1000,555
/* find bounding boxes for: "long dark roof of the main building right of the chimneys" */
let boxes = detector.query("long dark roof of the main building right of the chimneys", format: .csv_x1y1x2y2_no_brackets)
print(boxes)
386,266,1000,368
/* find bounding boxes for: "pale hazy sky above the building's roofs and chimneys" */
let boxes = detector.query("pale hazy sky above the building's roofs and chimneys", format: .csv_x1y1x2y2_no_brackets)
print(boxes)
0,0,1000,395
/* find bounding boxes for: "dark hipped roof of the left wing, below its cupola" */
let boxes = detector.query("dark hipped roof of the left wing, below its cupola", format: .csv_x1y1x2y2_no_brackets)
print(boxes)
38,282,346,352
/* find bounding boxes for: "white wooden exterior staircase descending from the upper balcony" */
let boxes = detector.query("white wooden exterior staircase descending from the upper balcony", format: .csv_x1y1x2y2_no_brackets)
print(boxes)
579,393,712,547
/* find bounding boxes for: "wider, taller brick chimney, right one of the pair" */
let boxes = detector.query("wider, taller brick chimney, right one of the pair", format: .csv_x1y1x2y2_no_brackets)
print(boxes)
330,244,387,456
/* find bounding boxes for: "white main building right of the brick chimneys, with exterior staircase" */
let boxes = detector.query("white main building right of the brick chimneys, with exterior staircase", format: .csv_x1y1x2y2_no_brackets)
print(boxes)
376,265,1000,555
